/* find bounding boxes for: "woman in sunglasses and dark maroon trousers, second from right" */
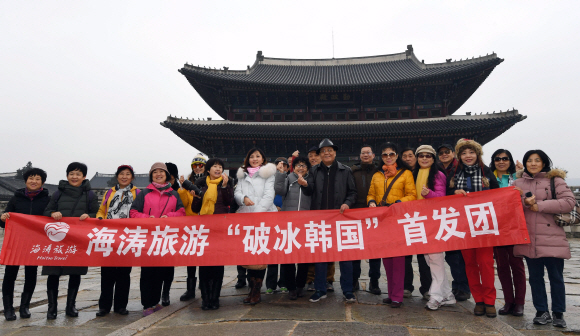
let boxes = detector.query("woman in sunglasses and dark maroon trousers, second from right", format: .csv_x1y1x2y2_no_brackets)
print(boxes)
489,149,526,316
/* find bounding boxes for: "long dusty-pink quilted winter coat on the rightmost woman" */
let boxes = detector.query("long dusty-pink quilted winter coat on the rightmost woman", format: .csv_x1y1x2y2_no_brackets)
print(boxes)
514,169,576,259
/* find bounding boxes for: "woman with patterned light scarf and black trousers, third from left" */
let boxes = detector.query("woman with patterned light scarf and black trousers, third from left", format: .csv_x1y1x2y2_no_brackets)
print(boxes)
96,165,141,316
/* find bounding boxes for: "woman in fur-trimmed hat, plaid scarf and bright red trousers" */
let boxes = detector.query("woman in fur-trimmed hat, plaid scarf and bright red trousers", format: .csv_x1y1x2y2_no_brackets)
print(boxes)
448,139,499,317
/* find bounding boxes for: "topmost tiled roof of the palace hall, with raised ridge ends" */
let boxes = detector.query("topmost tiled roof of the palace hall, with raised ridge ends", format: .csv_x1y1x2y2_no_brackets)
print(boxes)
179,45,503,90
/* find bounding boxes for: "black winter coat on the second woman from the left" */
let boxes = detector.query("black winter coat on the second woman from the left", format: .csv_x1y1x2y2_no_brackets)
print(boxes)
42,180,99,275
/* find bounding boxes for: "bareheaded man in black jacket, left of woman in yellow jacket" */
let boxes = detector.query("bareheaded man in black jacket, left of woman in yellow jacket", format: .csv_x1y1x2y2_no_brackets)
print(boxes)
351,144,381,295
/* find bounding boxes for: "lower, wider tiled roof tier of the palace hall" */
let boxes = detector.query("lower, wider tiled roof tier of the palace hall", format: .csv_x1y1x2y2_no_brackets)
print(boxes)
161,110,526,140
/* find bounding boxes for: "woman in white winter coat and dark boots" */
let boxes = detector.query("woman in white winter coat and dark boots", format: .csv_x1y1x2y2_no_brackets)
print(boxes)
234,148,278,305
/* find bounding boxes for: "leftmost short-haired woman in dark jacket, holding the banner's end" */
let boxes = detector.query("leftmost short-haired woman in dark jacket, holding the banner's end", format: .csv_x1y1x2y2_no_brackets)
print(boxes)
0,168,50,321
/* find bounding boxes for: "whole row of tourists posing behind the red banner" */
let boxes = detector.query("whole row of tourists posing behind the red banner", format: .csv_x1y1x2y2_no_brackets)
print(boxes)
1,139,576,327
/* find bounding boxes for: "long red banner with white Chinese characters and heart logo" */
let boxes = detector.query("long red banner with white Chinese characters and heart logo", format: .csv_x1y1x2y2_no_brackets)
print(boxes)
0,188,530,266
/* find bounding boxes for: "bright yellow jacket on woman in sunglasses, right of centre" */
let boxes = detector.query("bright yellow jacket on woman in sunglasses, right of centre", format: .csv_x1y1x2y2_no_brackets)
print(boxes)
367,170,417,205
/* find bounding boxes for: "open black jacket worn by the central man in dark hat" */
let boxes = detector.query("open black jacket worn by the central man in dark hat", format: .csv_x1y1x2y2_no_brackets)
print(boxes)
307,161,356,210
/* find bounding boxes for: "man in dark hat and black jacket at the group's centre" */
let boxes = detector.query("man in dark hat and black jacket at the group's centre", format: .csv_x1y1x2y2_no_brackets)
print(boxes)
308,139,356,302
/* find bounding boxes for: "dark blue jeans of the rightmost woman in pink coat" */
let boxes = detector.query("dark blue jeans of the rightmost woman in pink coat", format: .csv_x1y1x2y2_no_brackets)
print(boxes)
526,257,566,313
